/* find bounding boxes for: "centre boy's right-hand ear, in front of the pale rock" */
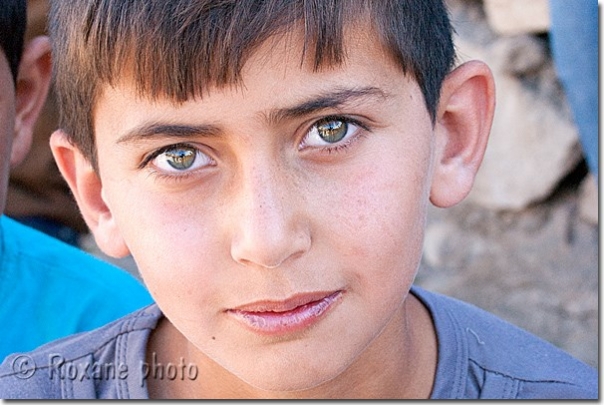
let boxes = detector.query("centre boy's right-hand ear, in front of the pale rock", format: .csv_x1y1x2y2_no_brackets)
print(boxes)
430,61,495,208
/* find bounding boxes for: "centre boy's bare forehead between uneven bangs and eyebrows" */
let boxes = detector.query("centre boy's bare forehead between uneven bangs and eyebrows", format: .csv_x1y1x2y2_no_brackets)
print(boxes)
106,21,404,104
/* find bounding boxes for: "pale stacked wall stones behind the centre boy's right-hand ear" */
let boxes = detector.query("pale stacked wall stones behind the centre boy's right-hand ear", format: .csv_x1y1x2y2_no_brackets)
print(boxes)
447,0,583,211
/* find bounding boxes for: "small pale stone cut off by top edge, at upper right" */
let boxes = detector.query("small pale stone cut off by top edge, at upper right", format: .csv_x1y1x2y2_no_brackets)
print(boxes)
484,0,550,35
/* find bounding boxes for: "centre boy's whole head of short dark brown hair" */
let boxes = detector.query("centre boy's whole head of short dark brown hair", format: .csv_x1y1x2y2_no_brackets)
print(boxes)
49,0,455,164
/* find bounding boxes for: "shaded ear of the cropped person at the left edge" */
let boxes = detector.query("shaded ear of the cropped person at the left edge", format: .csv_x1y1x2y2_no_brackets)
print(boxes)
10,36,51,166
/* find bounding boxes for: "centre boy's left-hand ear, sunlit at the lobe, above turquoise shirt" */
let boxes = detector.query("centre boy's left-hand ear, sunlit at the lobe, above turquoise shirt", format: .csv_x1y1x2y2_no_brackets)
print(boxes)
50,130,130,258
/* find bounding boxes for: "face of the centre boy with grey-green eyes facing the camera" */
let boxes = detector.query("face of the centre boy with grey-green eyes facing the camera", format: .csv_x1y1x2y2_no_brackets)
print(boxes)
59,22,492,390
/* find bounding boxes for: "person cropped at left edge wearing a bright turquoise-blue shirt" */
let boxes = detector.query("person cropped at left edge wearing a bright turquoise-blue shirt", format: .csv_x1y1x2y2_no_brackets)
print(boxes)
0,0,151,359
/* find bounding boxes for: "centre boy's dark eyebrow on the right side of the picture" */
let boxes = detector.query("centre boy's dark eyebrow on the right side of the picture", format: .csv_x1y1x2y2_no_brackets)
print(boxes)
267,87,389,123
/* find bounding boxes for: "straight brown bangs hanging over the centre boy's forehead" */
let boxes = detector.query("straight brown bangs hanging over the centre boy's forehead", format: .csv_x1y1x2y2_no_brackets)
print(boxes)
81,0,366,102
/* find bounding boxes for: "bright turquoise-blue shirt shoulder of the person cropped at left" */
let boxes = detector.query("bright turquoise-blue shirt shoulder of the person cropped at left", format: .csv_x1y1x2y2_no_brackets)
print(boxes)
0,216,153,359
